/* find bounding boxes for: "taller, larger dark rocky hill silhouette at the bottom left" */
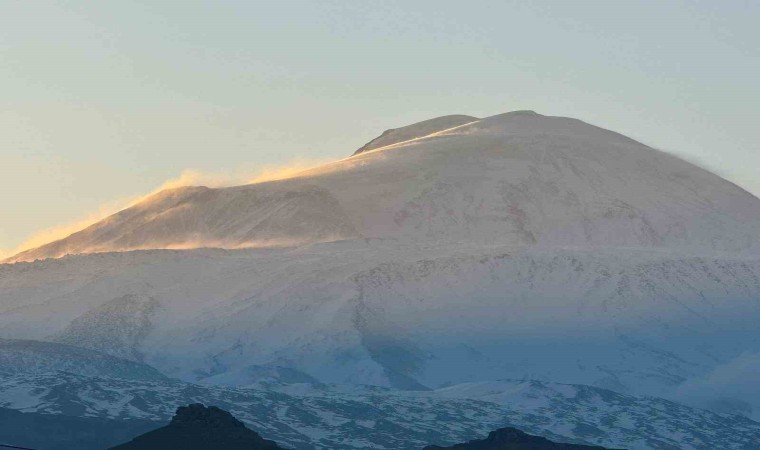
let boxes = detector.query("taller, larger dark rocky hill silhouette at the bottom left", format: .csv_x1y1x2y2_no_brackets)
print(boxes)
111,403,282,450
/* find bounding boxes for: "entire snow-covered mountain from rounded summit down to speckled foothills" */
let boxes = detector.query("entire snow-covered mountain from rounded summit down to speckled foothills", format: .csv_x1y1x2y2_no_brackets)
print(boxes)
0,111,760,442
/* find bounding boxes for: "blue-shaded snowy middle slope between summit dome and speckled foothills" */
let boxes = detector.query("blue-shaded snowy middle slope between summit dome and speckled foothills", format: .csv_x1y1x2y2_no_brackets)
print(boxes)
0,246,760,416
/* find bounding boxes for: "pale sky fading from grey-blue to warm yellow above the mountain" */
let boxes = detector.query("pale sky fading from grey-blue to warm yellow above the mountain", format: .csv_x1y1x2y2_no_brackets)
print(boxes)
0,0,760,253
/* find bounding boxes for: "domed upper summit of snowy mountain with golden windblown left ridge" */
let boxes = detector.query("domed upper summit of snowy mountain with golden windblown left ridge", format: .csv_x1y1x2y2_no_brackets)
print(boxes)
7,111,760,260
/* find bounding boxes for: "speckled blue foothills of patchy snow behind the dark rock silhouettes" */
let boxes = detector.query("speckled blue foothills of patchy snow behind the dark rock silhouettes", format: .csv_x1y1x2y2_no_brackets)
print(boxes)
0,373,760,450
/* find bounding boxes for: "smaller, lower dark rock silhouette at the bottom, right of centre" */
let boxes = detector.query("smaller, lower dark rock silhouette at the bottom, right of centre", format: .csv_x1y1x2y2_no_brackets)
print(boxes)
423,428,612,450
